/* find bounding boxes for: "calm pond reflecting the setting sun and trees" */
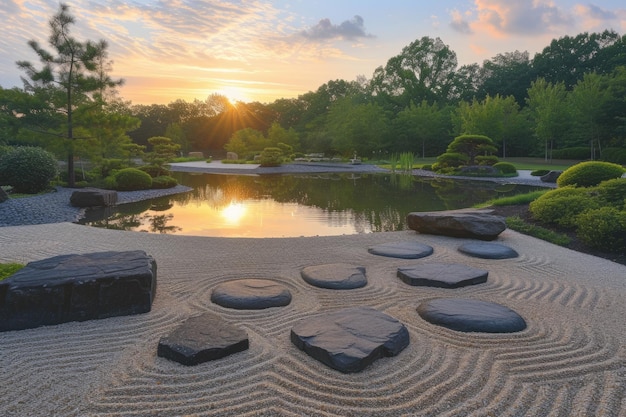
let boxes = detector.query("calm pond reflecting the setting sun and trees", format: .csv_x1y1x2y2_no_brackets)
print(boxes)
80,173,537,238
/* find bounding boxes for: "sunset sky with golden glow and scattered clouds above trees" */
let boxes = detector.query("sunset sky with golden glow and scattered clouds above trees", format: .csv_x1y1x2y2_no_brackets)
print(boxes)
0,0,626,104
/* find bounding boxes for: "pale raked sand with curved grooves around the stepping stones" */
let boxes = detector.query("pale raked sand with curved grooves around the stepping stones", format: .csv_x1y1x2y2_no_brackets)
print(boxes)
0,223,626,417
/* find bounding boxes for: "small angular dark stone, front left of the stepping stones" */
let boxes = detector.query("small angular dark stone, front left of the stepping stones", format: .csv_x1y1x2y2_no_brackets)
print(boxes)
157,313,249,366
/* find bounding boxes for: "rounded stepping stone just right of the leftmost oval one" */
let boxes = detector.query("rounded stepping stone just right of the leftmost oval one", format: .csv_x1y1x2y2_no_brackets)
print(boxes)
300,263,367,290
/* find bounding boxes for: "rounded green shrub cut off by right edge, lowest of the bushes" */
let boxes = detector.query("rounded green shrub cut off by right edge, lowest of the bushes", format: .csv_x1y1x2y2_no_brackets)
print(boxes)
577,207,626,253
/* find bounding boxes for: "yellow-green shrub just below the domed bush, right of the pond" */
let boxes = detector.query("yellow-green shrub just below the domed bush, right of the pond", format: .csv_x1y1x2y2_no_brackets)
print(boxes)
528,187,599,228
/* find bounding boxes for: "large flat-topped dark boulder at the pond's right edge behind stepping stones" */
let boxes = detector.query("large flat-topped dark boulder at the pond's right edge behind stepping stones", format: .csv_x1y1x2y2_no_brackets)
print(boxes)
407,210,506,240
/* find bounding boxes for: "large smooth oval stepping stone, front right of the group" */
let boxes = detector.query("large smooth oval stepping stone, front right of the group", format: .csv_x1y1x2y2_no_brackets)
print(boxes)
417,298,526,333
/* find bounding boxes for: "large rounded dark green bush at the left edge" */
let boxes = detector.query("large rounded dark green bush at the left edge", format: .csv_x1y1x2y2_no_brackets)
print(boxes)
0,147,59,194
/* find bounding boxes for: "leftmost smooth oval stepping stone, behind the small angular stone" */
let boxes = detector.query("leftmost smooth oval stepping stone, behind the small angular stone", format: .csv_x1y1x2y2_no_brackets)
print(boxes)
211,279,291,310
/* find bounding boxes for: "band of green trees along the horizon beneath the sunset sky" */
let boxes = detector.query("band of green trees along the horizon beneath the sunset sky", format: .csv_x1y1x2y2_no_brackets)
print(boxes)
0,4,626,185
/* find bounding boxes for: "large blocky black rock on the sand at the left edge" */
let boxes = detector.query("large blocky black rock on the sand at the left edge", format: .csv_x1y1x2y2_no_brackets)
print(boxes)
0,250,156,331
